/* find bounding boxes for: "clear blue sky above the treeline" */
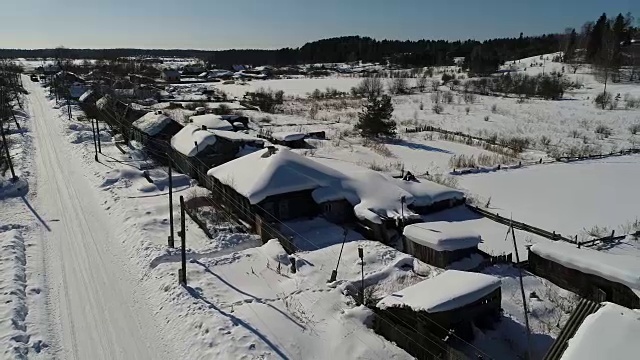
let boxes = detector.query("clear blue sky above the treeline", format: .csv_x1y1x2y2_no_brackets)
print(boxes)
0,0,640,49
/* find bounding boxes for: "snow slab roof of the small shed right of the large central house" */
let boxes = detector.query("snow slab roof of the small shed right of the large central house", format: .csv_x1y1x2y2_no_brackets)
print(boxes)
403,221,482,251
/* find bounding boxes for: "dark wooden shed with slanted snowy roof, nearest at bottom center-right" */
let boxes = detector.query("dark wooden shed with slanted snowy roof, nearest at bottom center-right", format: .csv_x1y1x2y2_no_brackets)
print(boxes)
374,270,502,360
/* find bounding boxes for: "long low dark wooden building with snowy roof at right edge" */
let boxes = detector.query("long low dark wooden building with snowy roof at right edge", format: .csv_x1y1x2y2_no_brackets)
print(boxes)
529,241,640,309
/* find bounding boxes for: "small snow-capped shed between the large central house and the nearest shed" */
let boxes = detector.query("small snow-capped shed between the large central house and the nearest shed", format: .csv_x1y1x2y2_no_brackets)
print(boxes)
403,221,482,268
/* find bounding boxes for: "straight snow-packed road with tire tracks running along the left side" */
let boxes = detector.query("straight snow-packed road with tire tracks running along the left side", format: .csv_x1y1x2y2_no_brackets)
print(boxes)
24,81,174,359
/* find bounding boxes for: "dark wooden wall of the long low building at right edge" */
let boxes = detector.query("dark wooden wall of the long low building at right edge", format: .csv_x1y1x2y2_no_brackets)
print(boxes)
529,251,640,309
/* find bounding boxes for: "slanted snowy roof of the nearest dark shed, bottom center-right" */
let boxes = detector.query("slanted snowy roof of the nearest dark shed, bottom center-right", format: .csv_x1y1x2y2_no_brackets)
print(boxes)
377,270,500,313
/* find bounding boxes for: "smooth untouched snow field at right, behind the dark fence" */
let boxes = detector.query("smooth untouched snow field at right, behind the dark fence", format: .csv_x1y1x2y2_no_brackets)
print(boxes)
459,155,640,240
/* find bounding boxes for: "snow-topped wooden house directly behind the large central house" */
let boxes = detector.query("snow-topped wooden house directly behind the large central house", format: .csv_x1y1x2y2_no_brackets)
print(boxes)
171,124,264,183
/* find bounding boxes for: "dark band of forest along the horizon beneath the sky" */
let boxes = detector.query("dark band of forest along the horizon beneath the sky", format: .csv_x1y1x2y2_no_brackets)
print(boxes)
0,14,637,73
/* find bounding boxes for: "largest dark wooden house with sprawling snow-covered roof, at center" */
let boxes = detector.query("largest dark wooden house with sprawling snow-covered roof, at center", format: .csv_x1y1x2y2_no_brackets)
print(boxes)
205,146,468,243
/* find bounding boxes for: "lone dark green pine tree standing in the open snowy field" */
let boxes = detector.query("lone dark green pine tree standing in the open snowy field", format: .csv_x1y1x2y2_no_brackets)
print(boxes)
355,95,396,138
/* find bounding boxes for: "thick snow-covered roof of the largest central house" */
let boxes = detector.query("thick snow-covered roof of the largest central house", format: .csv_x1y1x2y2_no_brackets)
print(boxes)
208,147,464,223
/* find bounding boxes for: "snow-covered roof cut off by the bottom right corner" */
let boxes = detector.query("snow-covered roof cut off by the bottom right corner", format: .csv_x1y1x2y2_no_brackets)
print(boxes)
561,303,640,360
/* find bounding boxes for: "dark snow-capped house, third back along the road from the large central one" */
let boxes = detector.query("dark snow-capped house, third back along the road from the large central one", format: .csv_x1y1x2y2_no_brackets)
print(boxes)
130,110,183,161
